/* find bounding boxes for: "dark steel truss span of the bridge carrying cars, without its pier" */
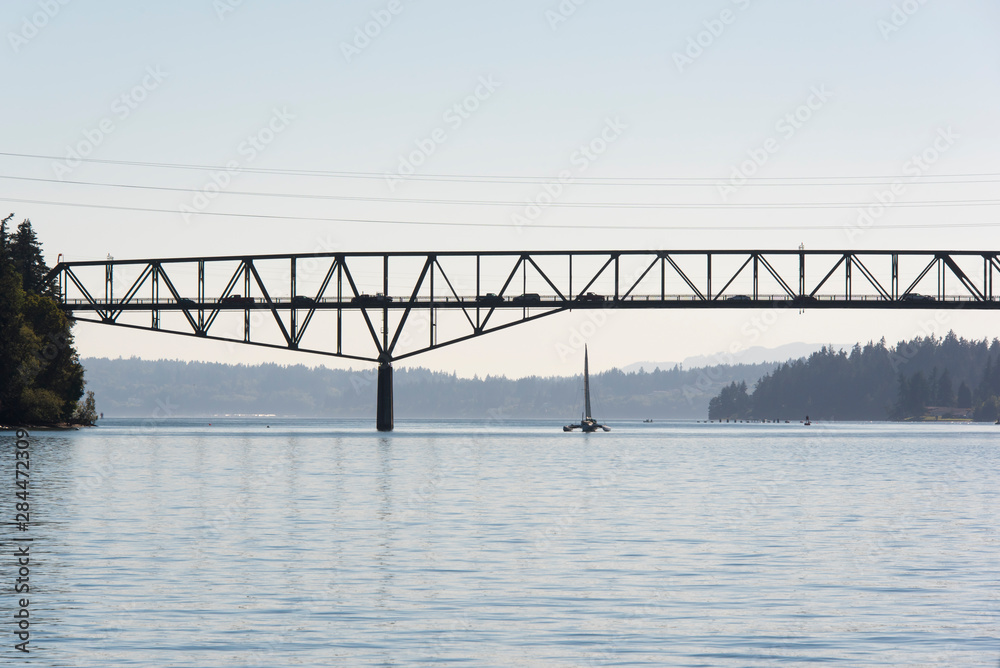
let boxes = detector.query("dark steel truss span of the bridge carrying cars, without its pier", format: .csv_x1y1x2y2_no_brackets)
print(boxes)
48,250,1000,363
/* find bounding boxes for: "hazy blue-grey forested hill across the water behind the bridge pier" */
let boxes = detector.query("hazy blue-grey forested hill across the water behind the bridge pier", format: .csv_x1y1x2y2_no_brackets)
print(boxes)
83,358,777,420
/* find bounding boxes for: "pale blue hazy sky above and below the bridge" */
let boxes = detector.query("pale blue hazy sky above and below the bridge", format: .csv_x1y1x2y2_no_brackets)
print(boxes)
0,0,1000,375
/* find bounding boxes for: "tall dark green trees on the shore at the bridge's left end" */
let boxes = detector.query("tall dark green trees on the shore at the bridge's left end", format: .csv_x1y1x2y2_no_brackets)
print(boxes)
0,214,96,425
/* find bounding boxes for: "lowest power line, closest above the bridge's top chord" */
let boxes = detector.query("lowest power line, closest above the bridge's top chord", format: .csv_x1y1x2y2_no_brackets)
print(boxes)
7,198,1000,231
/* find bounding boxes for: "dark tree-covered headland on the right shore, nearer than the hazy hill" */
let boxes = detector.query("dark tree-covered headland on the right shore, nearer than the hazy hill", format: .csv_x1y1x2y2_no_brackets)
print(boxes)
708,332,1000,421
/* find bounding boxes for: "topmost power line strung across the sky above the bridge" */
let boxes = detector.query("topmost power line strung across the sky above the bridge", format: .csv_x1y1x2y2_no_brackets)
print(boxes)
0,152,1000,186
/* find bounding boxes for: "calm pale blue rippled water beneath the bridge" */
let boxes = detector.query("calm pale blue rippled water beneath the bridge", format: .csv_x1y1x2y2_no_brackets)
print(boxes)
0,418,1000,668
